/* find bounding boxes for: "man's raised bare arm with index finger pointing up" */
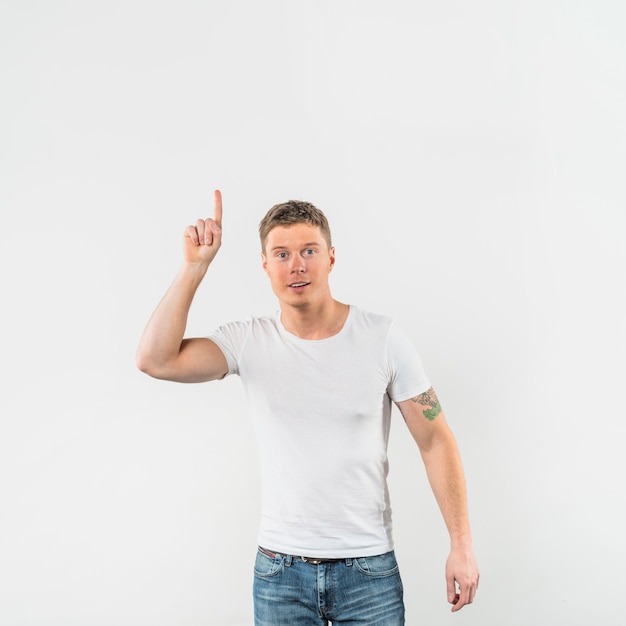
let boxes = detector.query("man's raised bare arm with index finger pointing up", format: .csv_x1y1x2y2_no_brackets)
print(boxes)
136,191,228,383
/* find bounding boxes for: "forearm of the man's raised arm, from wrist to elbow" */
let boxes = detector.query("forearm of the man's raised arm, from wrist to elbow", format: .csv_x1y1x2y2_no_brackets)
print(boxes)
137,263,208,373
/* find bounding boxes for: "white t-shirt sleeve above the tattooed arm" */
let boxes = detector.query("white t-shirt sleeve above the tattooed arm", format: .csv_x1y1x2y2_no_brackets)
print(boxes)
387,322,431,402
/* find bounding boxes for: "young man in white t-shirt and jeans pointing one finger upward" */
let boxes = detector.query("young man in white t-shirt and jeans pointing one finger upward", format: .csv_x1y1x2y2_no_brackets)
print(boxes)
137,191,479,626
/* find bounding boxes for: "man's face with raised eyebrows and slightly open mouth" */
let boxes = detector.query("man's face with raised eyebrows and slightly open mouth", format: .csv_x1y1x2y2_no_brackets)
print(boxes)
261,224,335,308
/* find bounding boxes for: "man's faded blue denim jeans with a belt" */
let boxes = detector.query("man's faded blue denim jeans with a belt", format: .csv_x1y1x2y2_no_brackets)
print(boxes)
254,550,404,626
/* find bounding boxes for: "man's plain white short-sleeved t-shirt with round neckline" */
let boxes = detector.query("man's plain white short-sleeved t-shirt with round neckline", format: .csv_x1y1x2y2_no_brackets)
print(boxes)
209,306,430,558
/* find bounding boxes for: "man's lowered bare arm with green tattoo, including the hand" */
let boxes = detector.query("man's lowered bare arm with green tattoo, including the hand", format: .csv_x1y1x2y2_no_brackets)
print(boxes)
398,387,479,611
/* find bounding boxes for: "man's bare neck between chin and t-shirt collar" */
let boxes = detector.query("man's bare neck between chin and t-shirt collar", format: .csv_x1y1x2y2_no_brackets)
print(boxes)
280,300,350,339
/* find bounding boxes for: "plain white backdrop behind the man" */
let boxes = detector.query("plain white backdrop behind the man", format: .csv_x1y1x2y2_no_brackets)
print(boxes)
0,0,626,626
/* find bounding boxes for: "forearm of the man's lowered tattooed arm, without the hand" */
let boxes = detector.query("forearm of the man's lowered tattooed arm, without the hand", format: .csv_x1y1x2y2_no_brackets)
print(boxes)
421,430,472,548
